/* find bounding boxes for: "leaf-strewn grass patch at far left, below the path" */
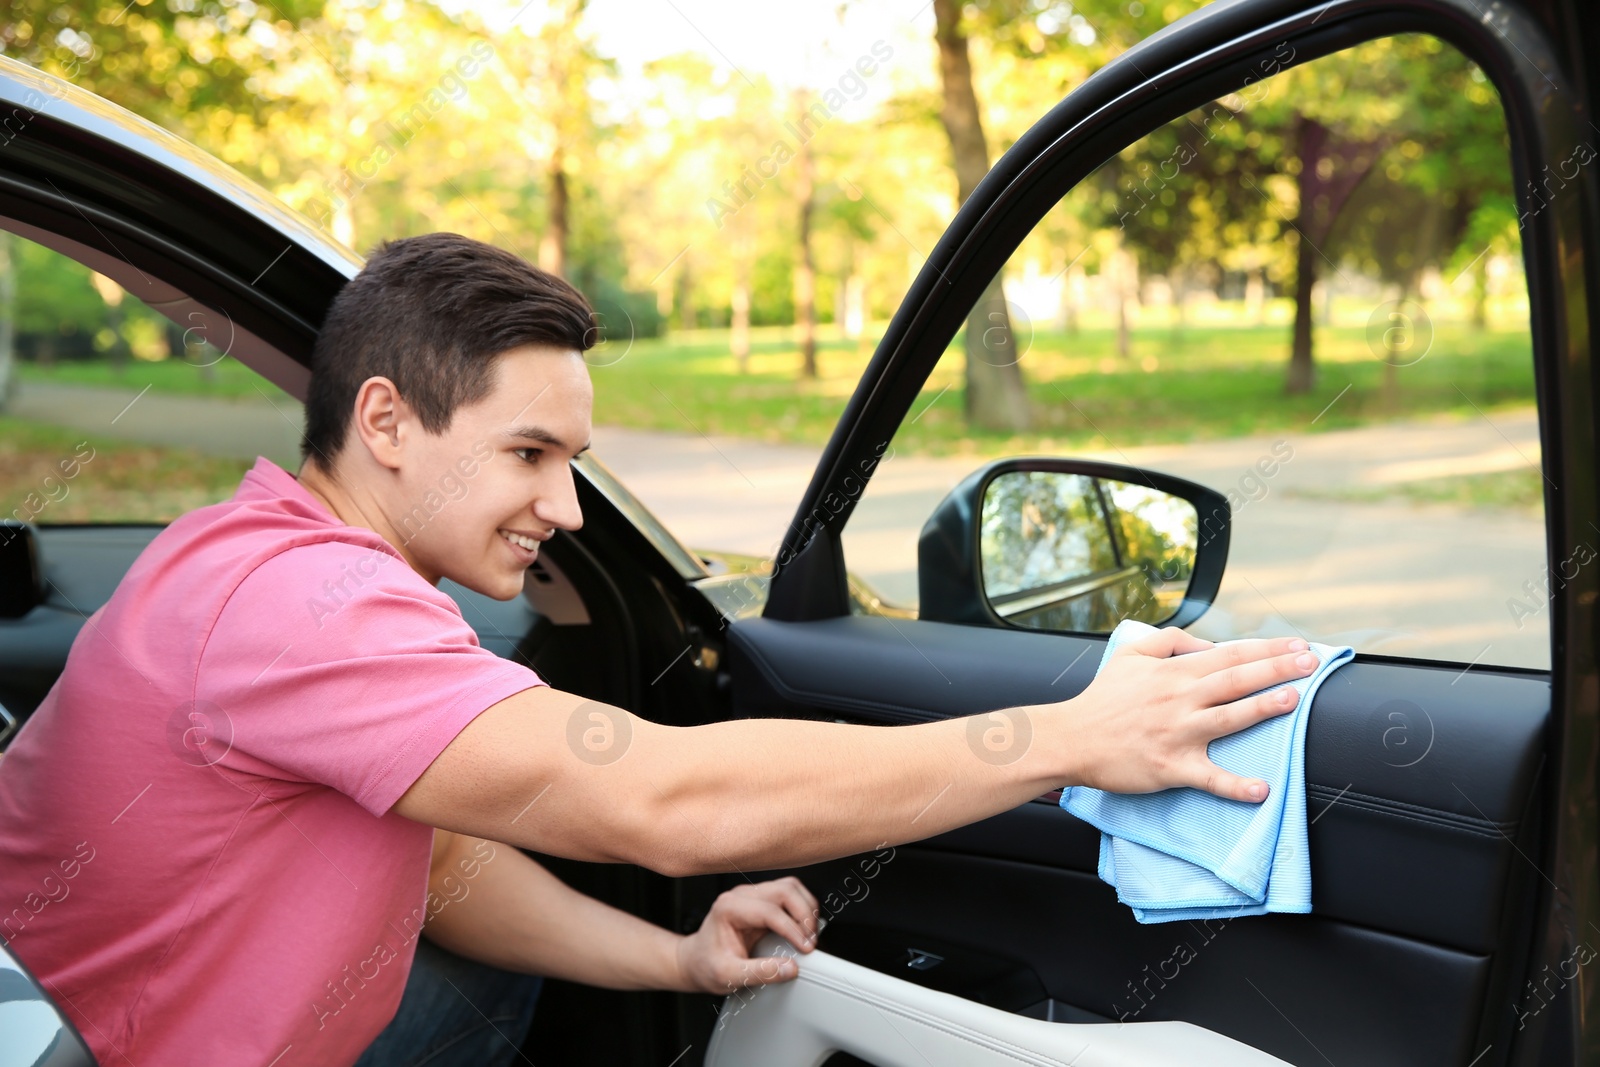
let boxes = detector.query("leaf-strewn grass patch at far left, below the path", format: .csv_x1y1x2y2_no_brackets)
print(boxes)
0,418,251,525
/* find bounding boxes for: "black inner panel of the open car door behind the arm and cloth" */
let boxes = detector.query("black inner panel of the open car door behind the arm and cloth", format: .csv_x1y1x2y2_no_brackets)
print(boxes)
730,616,1550,1064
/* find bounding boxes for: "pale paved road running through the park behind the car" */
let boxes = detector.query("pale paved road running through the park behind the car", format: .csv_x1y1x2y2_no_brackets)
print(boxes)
14,384,1549,665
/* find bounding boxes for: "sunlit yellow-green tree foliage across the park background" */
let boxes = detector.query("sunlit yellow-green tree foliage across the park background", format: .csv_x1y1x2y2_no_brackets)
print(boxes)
0,0,1520,428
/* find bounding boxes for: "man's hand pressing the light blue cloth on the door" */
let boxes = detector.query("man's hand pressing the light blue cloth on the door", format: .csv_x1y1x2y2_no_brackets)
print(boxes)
1062,627,1317,801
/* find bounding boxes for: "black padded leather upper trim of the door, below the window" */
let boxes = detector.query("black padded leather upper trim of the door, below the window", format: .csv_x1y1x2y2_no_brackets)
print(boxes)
730,616,1550,959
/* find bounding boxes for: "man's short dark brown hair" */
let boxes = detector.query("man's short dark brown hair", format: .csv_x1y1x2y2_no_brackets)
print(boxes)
301,234,598,467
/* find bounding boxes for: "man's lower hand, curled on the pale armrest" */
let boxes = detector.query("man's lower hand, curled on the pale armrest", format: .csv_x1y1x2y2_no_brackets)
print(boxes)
678,877,821,993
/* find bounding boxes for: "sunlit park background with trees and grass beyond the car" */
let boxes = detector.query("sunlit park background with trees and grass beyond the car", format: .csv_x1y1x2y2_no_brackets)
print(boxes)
0,0,1539,601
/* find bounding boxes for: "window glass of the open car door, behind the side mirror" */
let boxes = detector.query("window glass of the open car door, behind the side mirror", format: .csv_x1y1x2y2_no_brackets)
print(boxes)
845,35,1542,667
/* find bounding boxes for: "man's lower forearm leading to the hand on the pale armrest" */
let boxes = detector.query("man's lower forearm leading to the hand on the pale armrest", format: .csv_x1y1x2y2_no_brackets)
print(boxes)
422,830,686,990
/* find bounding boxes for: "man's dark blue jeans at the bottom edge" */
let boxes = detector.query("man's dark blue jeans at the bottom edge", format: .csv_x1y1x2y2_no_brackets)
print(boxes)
355,937,544,1067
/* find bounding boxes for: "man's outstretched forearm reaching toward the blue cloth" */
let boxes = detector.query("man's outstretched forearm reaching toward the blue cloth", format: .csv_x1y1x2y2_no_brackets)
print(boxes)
617,707,1064,873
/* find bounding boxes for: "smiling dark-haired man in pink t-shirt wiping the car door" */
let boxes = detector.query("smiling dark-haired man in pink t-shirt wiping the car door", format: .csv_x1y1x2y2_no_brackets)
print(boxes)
0,234,1315,1067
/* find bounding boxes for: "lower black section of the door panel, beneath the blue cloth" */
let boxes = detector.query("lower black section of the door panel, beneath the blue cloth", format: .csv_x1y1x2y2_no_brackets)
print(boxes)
742,846,1493,1067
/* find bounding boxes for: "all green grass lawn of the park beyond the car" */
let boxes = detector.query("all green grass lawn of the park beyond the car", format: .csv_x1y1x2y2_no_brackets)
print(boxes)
0,313,1541,523
